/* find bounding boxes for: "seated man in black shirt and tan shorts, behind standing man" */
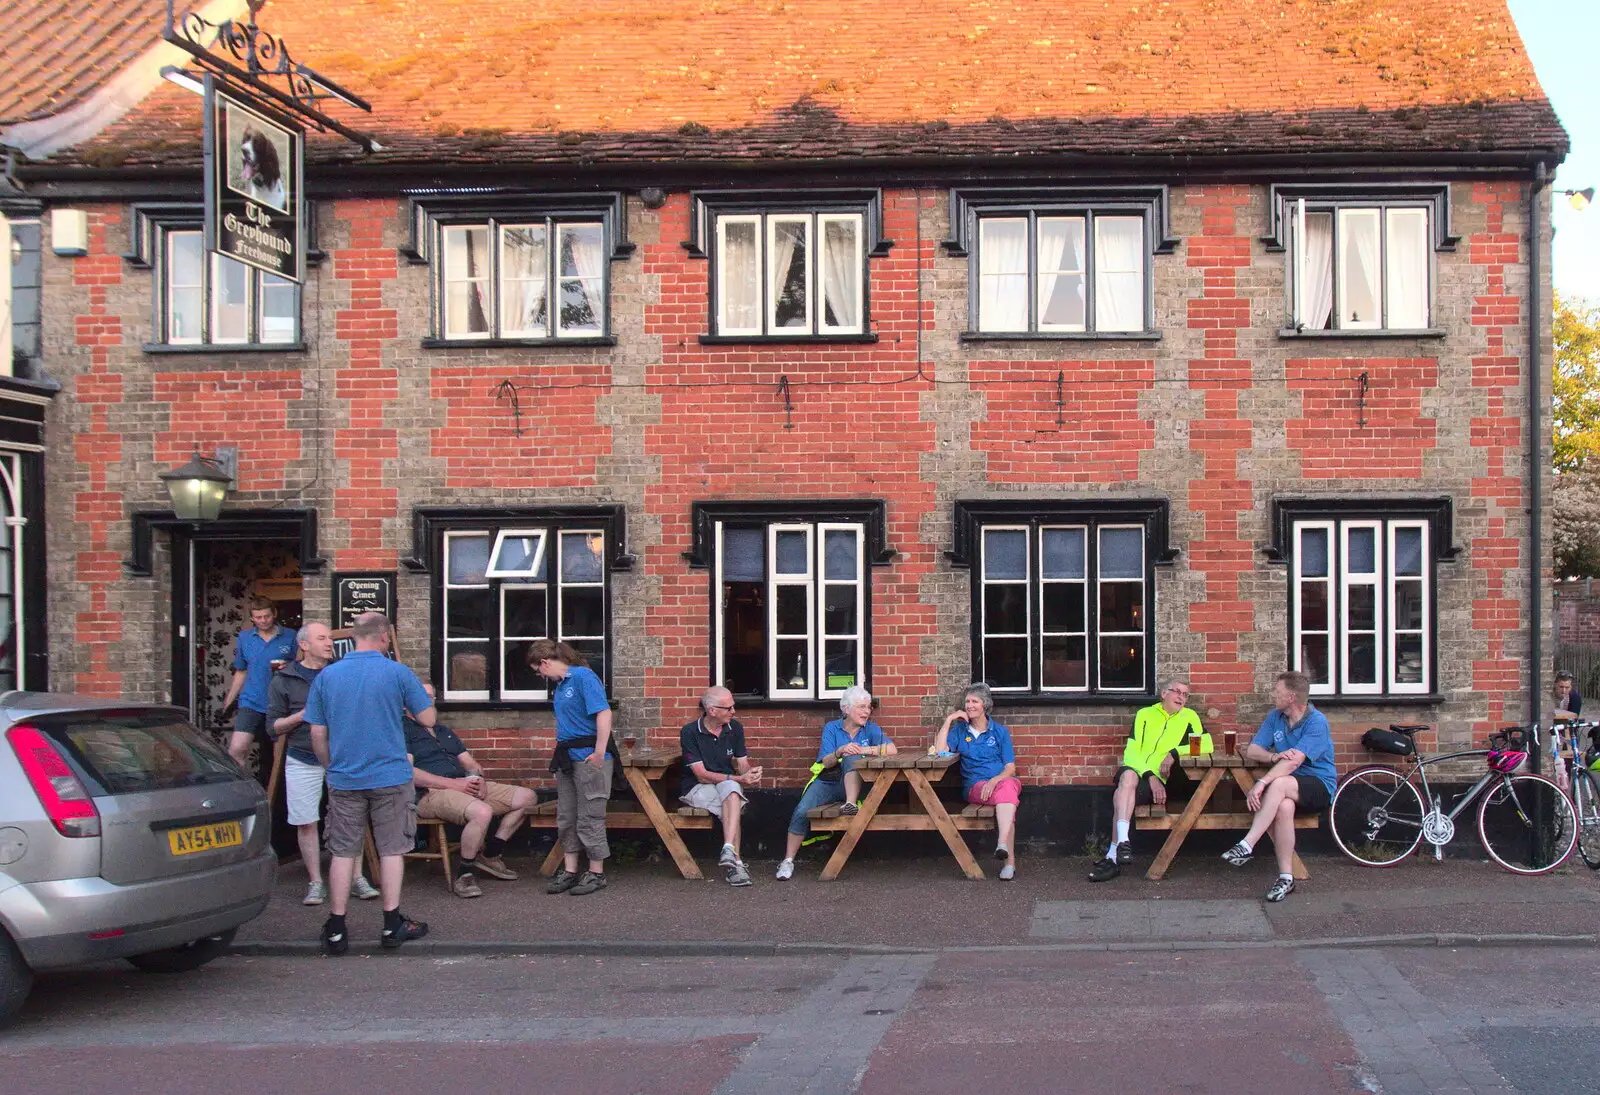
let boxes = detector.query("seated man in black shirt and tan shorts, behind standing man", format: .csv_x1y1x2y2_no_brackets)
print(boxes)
405,685,536,896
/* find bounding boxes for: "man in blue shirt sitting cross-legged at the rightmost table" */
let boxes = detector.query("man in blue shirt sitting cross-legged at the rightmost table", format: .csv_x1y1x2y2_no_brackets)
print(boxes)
1222,672,1338,901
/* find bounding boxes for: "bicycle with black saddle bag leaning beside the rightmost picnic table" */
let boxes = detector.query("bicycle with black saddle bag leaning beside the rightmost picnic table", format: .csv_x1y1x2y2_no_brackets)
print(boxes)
1330,725,1578,874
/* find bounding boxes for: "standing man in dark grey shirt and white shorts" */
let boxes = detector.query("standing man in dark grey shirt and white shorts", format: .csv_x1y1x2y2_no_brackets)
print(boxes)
267,623,378,904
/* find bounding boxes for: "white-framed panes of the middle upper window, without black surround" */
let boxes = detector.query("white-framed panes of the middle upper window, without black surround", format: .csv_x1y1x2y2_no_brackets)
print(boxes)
715,211,866,338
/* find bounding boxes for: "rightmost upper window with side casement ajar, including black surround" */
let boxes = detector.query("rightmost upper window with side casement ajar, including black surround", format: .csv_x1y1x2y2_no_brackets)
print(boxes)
1267,184,1454,333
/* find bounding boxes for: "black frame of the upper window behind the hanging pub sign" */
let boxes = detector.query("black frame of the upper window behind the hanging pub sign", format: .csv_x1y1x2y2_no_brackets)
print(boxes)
123,202,308,354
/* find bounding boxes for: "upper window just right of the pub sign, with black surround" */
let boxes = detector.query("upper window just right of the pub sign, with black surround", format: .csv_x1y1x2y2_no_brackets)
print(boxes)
400,191,634,347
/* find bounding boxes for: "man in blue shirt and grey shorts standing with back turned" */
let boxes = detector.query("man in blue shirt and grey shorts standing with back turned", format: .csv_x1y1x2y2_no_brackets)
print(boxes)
306,612,434,954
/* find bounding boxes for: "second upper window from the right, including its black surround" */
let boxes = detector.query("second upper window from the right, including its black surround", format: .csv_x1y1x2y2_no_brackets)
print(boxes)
944,187,1176,338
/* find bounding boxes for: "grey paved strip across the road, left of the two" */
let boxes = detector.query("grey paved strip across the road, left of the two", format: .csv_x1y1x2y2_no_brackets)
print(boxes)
715,954,938,1095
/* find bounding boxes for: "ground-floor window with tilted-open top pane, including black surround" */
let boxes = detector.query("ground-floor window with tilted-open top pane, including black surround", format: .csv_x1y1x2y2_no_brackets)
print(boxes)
408,506,630,703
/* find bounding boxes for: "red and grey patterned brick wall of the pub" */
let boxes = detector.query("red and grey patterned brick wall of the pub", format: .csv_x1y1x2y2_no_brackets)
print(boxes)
45,183,1547,784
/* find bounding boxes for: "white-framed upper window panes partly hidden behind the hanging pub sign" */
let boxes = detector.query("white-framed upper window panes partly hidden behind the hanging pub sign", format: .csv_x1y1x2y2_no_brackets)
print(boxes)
154,227,299,346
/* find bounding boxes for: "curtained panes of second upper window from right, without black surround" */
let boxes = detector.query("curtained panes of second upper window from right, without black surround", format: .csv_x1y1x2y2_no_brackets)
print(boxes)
974,210,1149,335
